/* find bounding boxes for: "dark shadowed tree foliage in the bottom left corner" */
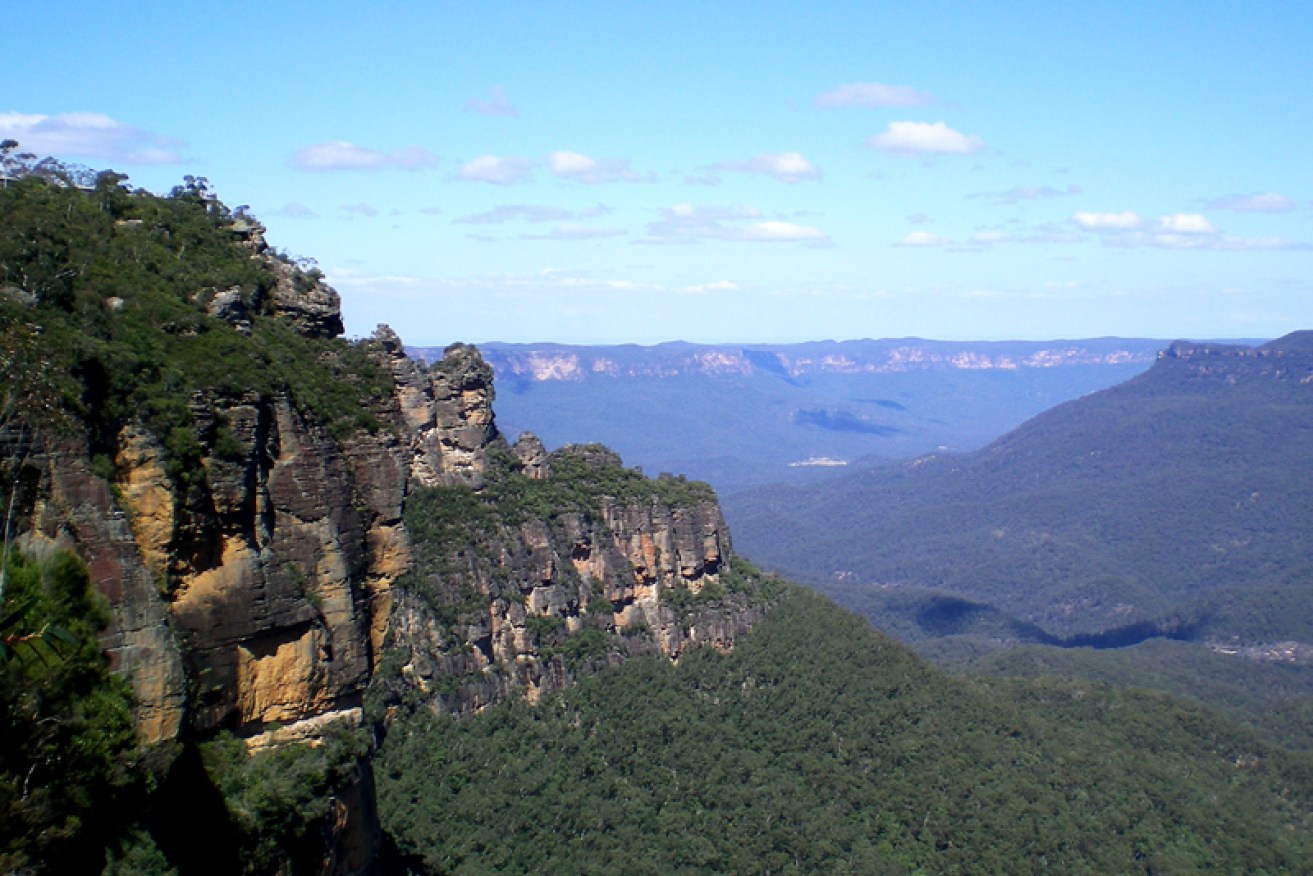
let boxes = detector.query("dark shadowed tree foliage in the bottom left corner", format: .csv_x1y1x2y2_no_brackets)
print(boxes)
0,552,147,873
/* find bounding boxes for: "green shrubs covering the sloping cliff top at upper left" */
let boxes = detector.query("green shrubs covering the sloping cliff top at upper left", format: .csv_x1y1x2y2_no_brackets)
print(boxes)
0,164,391,471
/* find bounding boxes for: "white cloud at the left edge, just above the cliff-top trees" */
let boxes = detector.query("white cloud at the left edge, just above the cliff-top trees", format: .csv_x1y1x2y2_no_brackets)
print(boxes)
0,113,181,164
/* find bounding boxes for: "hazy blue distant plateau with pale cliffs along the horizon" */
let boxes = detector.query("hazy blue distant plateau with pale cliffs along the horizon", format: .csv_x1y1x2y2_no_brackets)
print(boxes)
408,338,1167,493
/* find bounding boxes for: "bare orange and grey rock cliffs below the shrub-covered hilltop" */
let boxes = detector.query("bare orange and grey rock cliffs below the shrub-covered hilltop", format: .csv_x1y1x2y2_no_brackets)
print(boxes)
17,304,760,741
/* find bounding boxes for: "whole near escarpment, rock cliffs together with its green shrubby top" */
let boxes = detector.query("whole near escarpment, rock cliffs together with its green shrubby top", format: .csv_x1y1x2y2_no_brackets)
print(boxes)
0,174,772,873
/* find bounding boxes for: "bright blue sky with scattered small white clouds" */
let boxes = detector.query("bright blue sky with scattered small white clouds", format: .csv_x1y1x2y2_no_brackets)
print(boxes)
0,0,1313,344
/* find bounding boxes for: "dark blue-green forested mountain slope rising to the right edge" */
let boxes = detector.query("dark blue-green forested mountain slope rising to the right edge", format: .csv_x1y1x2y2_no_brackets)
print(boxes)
726,332,1313,662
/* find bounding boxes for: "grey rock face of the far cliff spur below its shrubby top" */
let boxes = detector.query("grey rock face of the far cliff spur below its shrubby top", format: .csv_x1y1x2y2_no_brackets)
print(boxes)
381,462,762,714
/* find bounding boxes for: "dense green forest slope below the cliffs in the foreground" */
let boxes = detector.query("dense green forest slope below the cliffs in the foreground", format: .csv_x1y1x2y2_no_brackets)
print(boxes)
376,591,1313,873
